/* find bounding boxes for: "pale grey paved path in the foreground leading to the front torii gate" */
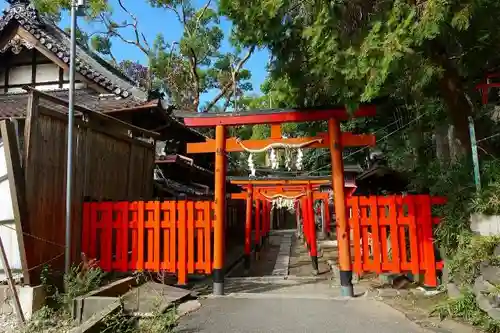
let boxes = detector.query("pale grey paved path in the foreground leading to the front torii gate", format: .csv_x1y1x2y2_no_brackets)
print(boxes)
177,278,436,333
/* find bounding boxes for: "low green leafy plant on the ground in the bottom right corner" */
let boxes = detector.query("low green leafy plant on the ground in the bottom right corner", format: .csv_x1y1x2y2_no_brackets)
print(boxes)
431,291,500,333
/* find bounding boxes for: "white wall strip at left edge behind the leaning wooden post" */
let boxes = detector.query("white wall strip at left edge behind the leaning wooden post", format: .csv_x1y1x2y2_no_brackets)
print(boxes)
0,138,21,281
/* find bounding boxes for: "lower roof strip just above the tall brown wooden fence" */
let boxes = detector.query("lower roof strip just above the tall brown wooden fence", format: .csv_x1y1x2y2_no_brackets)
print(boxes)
0,89,154,119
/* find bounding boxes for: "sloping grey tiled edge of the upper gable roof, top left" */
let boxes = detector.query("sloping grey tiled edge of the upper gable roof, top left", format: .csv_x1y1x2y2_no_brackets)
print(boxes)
0,0,147,101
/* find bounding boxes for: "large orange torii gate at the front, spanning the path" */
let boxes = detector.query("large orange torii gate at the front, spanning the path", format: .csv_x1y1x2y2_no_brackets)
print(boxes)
175,105,376,297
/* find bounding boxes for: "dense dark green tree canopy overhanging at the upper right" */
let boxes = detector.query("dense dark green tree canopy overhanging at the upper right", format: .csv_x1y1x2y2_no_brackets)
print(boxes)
219,0,500,149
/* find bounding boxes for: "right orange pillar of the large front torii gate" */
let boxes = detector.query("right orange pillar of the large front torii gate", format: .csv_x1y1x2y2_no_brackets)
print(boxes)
328,118,354,297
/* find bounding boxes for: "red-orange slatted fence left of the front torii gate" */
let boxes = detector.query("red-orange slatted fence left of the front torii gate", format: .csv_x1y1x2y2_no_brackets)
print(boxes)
82,200,244,284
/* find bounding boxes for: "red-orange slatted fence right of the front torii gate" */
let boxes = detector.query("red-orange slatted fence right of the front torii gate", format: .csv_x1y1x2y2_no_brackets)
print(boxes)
347,195,445,286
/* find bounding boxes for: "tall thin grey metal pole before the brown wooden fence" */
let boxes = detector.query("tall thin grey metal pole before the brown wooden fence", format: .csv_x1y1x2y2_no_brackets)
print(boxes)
64,0,78,274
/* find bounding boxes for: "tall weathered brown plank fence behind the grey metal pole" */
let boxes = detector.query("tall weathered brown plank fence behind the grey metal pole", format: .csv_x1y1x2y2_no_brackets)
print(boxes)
8,90,156,284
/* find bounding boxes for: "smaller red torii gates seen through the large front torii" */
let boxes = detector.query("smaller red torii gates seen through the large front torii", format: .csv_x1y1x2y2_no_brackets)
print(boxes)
230,175,362,275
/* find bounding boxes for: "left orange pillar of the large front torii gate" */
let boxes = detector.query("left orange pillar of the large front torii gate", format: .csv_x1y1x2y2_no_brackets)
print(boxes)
212,125,226,295
